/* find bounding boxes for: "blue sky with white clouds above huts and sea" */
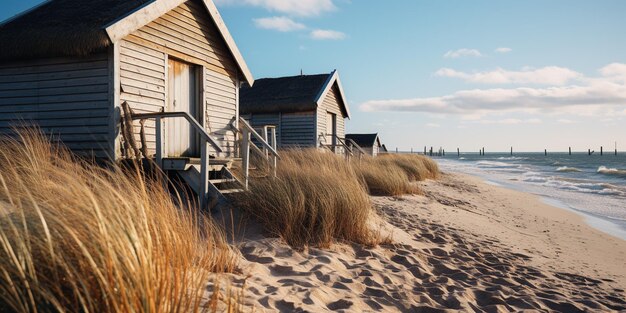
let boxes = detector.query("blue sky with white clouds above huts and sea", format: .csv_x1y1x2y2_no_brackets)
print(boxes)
0,0,626,152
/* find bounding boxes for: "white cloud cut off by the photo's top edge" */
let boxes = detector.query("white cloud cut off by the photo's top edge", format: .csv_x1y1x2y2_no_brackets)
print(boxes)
215,0,337,16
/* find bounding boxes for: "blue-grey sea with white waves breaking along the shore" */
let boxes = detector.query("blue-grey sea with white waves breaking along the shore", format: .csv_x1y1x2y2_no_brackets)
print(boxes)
436,152,626,240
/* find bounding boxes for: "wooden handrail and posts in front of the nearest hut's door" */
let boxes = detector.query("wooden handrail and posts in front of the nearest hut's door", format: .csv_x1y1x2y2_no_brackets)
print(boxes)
131,112,224,208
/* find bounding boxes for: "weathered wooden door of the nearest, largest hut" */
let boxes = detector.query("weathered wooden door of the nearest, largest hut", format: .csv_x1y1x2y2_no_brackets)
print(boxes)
165,60,201,157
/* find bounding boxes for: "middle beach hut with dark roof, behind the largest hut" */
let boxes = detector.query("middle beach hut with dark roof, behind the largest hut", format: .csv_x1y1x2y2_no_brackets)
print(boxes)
240,71,350,153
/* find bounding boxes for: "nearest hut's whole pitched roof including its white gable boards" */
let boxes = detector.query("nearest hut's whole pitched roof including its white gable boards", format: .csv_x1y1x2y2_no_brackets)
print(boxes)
0,0,254,84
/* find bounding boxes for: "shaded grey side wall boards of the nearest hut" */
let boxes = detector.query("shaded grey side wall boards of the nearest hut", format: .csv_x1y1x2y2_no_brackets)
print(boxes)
0,54,113,157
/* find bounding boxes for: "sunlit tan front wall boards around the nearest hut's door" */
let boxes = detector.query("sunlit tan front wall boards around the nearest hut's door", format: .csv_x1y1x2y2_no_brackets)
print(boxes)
120,0,239,155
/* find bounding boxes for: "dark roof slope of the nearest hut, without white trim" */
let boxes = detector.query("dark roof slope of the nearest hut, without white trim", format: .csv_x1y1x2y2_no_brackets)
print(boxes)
0,0,155,61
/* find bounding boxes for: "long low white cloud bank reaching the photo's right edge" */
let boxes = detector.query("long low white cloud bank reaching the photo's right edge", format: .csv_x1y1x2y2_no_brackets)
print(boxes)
361,64,626,118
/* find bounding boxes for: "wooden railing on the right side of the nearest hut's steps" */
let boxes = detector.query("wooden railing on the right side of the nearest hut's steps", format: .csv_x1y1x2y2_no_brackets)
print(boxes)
237,117,279,190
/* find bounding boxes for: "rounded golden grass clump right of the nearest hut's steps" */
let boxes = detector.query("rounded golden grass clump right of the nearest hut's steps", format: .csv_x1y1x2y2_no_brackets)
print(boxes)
229,149,378,248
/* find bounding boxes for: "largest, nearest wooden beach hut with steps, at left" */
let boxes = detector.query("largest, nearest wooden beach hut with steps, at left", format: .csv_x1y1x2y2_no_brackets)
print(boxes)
0,0,272,206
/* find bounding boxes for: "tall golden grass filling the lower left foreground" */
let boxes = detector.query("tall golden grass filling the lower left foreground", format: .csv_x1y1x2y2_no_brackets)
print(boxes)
0,131,235,312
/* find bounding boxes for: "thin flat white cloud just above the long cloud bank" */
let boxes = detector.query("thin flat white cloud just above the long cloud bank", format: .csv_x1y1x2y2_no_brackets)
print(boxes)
435,66,583,85
